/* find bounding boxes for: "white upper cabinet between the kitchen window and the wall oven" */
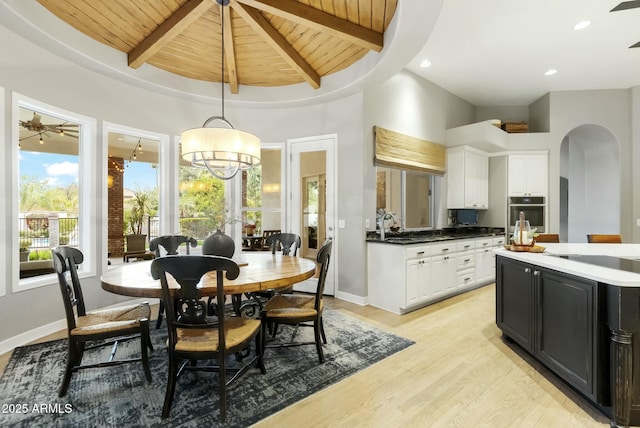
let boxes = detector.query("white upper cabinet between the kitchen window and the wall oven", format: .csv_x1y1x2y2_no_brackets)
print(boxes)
447,147,489,210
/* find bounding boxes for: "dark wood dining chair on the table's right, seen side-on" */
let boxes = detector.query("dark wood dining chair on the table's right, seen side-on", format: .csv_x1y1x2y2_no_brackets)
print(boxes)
261,240,333,364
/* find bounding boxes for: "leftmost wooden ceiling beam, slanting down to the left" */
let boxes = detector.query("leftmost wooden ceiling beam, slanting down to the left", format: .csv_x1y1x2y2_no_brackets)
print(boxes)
128,0,214,68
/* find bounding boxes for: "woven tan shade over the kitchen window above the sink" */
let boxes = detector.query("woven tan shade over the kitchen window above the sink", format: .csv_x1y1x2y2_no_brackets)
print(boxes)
373,126,446,175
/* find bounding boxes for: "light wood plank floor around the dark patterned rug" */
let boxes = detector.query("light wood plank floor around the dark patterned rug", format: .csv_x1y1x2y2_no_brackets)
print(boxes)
0,285,609,428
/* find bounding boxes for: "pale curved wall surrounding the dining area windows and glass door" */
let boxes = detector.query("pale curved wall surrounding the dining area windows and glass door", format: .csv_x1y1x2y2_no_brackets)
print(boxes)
0,26,366,343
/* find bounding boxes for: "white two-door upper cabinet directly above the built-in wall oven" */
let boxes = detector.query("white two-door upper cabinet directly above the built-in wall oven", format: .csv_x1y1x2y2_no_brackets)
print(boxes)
508,154,549,196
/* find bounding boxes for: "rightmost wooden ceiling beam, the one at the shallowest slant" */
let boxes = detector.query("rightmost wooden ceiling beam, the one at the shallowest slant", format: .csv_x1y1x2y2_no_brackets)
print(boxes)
236,0,383,52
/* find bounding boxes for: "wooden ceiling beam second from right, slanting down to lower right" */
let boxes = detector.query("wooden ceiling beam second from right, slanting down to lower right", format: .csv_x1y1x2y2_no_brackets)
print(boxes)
231,2,320,89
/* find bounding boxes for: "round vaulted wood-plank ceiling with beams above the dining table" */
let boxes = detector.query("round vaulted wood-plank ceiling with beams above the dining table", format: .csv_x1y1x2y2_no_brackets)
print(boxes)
38,0,397,93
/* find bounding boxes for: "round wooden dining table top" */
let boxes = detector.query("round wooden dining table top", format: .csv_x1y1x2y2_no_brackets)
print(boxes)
100,251,316,298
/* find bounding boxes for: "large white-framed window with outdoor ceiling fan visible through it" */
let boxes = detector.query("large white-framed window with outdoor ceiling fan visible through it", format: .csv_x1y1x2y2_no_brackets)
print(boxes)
13,94,96,291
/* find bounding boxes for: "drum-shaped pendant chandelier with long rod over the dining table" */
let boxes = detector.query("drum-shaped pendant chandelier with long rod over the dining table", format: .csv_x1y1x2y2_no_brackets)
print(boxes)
181,0,260,180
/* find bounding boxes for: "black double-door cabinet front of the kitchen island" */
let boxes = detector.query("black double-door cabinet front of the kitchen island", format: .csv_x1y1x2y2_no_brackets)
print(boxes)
496,256,607,400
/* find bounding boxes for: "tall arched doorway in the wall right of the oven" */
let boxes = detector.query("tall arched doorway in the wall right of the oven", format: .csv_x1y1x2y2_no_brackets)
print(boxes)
560,124,620,242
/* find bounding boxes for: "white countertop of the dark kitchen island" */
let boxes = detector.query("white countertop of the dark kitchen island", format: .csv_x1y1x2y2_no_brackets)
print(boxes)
495,243,640,287
